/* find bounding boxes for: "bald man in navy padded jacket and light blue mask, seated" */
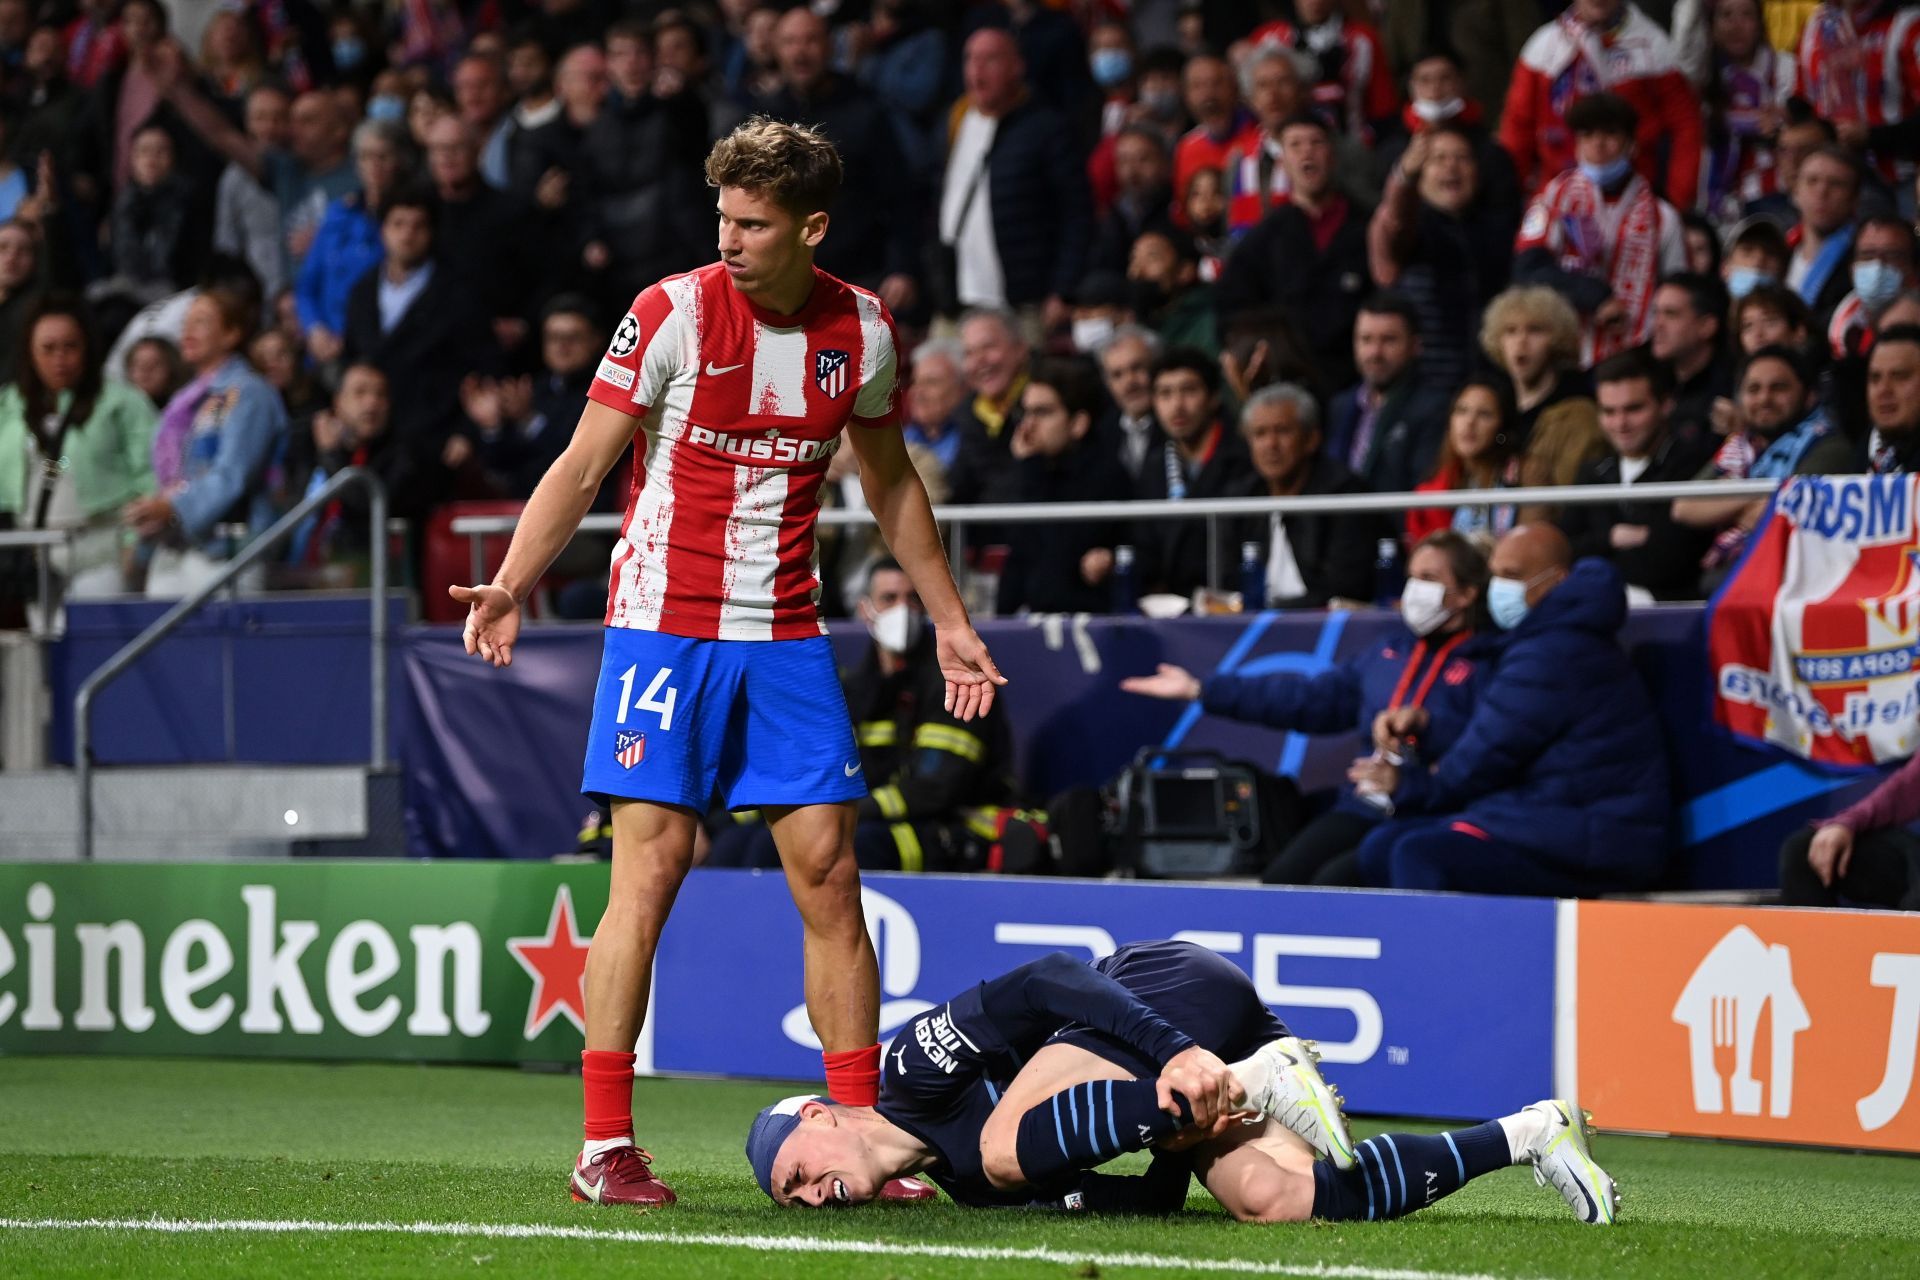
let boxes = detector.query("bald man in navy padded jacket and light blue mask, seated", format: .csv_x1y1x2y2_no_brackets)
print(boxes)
1354,524,1670,896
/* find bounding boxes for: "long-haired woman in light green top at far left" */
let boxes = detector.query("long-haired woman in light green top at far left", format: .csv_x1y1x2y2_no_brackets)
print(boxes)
0,296,156,599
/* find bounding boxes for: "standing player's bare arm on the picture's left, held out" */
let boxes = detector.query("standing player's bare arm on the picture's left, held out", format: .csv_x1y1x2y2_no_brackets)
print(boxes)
447,399,634,666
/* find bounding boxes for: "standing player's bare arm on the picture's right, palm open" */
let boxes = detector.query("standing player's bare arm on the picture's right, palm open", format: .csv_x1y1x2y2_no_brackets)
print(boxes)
849,426,1006,720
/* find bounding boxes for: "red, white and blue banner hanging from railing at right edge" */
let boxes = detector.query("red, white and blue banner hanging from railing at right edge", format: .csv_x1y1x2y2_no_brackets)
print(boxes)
1707,476,1920,766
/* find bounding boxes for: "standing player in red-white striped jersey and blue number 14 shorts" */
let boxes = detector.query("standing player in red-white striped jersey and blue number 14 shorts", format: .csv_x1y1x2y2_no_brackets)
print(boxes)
453,119,1006,1205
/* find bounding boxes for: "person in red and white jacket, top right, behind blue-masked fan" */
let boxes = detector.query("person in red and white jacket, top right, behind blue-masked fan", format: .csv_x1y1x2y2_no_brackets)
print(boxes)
1500,0,1705,209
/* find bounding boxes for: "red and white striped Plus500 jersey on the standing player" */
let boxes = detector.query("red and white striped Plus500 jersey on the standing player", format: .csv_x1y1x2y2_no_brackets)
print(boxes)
588,263,899,641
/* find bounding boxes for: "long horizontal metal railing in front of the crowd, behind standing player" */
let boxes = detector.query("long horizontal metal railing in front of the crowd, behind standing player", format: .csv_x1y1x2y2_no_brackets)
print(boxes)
441,480,1782,602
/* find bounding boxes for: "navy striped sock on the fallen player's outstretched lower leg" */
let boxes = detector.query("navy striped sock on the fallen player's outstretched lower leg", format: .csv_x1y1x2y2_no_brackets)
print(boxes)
1313,1121,1513,1222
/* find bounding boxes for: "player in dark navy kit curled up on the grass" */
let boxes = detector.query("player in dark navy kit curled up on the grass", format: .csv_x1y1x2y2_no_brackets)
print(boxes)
747,942,1619,1224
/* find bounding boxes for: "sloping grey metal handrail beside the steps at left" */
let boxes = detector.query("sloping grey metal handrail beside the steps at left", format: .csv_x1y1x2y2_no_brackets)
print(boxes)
73,466,388,862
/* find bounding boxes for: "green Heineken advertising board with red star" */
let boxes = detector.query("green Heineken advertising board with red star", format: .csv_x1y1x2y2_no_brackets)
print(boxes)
0,862,607,1061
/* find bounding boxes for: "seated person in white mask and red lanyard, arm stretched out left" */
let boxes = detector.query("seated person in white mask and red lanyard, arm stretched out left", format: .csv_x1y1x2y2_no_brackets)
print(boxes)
1119,532,1500,885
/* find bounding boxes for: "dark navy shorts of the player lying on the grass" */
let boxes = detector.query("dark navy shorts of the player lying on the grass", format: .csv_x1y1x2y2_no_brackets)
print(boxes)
1052,942,1290,1080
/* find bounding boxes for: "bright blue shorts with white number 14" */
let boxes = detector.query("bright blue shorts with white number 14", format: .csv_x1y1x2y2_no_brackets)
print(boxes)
580,628,866,812
